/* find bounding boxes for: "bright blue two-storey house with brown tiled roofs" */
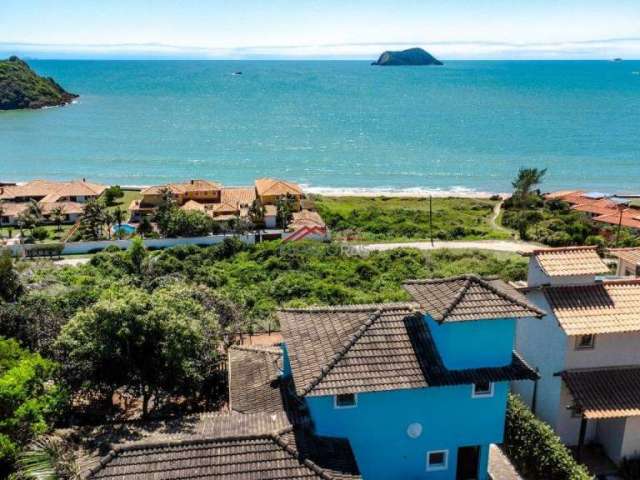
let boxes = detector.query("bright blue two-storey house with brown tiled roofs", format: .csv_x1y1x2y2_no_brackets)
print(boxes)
278,276,544,480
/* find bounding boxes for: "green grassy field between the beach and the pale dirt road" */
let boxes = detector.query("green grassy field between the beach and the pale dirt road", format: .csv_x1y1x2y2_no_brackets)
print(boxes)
315,197,511,241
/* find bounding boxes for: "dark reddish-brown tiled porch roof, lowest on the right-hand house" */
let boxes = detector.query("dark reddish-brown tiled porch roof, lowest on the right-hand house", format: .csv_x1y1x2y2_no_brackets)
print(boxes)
561,366,640,419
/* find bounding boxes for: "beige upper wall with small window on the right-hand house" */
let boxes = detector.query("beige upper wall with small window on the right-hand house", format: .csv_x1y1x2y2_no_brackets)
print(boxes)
566,332,640,369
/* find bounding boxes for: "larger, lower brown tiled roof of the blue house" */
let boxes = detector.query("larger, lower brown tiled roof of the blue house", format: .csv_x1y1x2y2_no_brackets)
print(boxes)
278,304,535,396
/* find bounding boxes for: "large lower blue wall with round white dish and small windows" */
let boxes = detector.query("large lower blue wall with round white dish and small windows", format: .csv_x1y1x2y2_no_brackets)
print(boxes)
306,382,508,480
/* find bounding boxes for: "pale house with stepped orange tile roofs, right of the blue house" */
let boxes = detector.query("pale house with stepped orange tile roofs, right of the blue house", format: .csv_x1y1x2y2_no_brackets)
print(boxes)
513,247,640,462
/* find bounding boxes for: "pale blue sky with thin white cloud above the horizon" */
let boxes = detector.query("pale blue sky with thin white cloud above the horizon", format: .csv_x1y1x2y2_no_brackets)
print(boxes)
0,0,640,59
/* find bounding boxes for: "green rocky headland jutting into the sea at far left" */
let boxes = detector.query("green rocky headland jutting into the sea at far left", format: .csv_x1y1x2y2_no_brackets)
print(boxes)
0,57,78,110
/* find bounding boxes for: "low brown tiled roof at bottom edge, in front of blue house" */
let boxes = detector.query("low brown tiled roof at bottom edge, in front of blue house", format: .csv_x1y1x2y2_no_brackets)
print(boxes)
85,413,360,480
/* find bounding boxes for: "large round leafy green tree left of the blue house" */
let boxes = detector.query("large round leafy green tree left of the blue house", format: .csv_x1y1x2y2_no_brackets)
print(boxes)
57,283,221,416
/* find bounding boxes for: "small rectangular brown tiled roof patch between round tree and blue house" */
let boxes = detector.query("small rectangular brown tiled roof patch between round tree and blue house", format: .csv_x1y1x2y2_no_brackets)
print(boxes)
228,346,285,413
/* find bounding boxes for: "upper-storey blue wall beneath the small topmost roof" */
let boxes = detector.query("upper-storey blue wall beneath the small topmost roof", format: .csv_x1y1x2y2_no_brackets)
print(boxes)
425,316,516,370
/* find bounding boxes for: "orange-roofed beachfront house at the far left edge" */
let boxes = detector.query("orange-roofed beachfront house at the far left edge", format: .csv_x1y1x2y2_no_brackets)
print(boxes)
0,179,107,203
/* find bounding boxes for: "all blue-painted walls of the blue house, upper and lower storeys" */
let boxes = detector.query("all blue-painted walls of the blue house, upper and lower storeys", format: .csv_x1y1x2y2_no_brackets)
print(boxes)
283,317,515,480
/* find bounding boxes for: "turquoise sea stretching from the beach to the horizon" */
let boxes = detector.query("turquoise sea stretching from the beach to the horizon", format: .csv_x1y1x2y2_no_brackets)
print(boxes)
0,61,640,193
